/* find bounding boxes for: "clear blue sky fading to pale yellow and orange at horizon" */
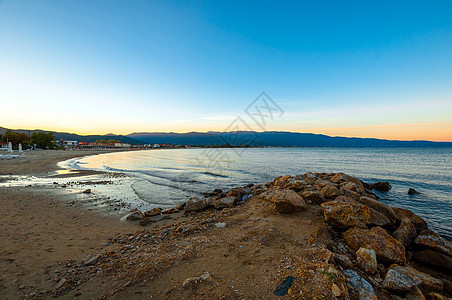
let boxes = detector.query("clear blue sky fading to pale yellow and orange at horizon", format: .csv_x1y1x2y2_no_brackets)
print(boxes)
0,0,452,141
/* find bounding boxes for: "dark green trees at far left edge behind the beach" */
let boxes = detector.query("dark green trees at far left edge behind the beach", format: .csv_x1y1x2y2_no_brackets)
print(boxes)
0,129,56,149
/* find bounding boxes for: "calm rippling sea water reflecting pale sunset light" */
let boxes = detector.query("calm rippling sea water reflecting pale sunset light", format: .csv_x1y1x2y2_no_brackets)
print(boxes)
68,148,452,239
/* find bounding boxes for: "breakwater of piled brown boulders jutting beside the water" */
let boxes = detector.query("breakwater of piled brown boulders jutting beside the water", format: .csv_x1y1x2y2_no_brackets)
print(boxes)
117,173,452,299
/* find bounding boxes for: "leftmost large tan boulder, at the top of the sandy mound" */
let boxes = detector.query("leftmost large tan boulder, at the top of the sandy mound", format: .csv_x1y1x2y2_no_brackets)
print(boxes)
259,188,306,213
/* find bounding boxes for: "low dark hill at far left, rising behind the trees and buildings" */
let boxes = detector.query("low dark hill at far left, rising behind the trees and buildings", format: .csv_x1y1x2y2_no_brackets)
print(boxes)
0,127,144,145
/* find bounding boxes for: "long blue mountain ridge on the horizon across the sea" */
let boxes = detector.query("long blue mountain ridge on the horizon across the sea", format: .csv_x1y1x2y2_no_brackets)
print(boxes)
127,131,452,148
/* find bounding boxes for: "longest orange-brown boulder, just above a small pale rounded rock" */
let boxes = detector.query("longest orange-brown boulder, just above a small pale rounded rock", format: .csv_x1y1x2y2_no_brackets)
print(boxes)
344,227,406,264
